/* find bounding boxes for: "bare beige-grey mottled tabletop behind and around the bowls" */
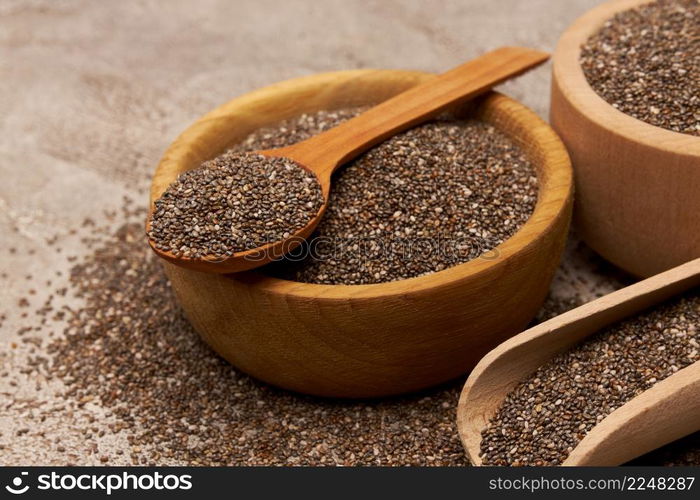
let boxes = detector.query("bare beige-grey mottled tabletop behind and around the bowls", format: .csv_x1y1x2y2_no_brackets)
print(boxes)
0,0,644,464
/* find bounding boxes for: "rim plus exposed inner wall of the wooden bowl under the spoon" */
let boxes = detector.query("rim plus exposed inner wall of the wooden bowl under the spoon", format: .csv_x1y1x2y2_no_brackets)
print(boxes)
151,70,572,298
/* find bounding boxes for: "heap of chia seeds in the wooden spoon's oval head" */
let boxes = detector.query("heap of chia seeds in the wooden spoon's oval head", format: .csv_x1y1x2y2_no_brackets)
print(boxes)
148,153,323,258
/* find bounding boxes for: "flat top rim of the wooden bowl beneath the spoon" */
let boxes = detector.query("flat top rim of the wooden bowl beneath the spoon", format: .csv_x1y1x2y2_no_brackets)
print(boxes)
150,69,573,300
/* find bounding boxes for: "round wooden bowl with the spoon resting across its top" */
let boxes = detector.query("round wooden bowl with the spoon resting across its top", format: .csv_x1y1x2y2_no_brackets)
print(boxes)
151,70,573,398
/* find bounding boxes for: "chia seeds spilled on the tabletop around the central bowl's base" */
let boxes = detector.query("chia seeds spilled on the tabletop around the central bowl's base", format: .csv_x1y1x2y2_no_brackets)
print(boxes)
39,217,466,465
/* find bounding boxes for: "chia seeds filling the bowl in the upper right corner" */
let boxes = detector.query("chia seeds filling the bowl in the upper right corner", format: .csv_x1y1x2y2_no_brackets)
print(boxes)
581,0,700,135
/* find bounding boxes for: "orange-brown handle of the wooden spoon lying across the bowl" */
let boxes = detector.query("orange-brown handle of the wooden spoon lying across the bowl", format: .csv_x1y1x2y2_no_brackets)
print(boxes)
275,47,549,180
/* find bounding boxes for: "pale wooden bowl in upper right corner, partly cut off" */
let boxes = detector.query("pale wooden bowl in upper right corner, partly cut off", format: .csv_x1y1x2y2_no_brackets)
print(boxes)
550,0,700,277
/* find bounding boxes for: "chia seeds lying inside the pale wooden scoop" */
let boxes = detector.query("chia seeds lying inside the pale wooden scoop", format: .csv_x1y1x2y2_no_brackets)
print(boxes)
481,290,700,465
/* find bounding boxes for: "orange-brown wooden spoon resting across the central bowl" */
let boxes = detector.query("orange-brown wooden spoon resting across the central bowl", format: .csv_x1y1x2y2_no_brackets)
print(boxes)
148,47,549,273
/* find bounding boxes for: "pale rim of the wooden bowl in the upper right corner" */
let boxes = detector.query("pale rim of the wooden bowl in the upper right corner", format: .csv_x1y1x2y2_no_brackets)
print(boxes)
552,0,700,156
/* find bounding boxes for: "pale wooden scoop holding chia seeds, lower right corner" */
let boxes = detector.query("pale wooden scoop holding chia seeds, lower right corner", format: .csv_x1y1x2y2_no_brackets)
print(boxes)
457,259,700,466
